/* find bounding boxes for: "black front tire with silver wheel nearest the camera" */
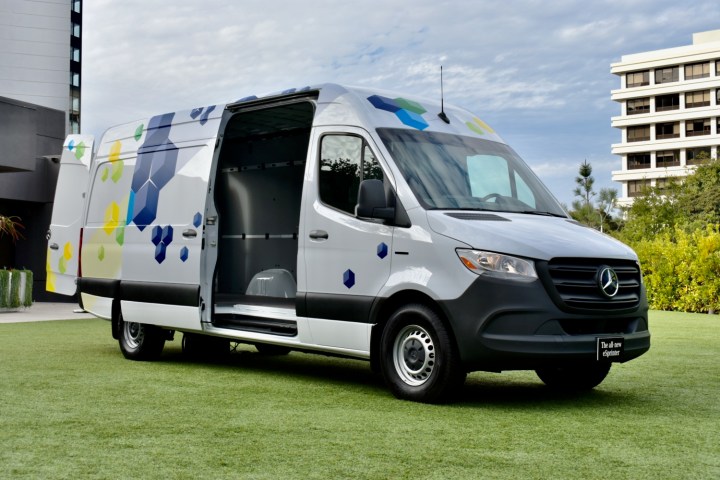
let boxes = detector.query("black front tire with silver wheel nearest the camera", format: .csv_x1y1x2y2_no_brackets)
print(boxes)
380,304,466,403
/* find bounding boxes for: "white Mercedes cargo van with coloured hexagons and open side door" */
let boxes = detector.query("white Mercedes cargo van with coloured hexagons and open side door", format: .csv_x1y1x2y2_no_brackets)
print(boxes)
47,84,650,402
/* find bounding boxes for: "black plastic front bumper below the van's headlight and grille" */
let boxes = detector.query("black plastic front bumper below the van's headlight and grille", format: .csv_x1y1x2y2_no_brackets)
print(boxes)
440,276,650,371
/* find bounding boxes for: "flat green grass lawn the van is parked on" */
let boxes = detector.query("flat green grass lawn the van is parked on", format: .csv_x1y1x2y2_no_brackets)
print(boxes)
0,312,720,479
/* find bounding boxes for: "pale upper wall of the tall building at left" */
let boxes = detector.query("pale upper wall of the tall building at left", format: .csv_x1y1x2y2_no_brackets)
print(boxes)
0,0,71,111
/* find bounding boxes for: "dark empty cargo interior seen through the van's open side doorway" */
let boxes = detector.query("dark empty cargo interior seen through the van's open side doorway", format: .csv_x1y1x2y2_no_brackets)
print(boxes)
214,101,314,309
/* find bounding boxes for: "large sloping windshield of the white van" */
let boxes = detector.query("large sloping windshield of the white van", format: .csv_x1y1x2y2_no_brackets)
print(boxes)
378,128,567,217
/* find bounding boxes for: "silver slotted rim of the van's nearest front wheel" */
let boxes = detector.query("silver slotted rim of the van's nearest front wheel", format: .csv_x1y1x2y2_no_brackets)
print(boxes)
393,325,435,387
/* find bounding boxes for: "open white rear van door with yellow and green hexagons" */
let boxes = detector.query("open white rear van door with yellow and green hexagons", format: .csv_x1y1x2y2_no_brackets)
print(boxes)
45,135,94,295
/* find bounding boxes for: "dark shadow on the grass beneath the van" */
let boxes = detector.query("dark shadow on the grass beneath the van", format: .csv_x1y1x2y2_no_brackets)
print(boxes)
139,345,645,410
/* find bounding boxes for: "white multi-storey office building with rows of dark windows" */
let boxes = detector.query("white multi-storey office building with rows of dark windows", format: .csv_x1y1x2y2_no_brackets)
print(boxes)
611,30,720,206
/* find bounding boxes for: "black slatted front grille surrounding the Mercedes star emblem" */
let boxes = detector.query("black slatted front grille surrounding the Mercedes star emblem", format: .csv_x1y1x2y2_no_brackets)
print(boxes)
540,258,641,311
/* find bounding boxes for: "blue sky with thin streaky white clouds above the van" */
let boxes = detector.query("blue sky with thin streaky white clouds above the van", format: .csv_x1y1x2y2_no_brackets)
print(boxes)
81,0,720,205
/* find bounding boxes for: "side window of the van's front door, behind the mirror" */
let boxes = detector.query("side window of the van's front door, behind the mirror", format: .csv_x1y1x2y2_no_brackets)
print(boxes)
318,135,383,215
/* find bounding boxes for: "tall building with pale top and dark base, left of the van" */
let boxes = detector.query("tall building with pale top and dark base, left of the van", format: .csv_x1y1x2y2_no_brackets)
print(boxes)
0,0,82,299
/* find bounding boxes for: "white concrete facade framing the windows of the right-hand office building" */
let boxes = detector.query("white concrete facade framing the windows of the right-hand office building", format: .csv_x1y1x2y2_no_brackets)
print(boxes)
611,30,720,205
